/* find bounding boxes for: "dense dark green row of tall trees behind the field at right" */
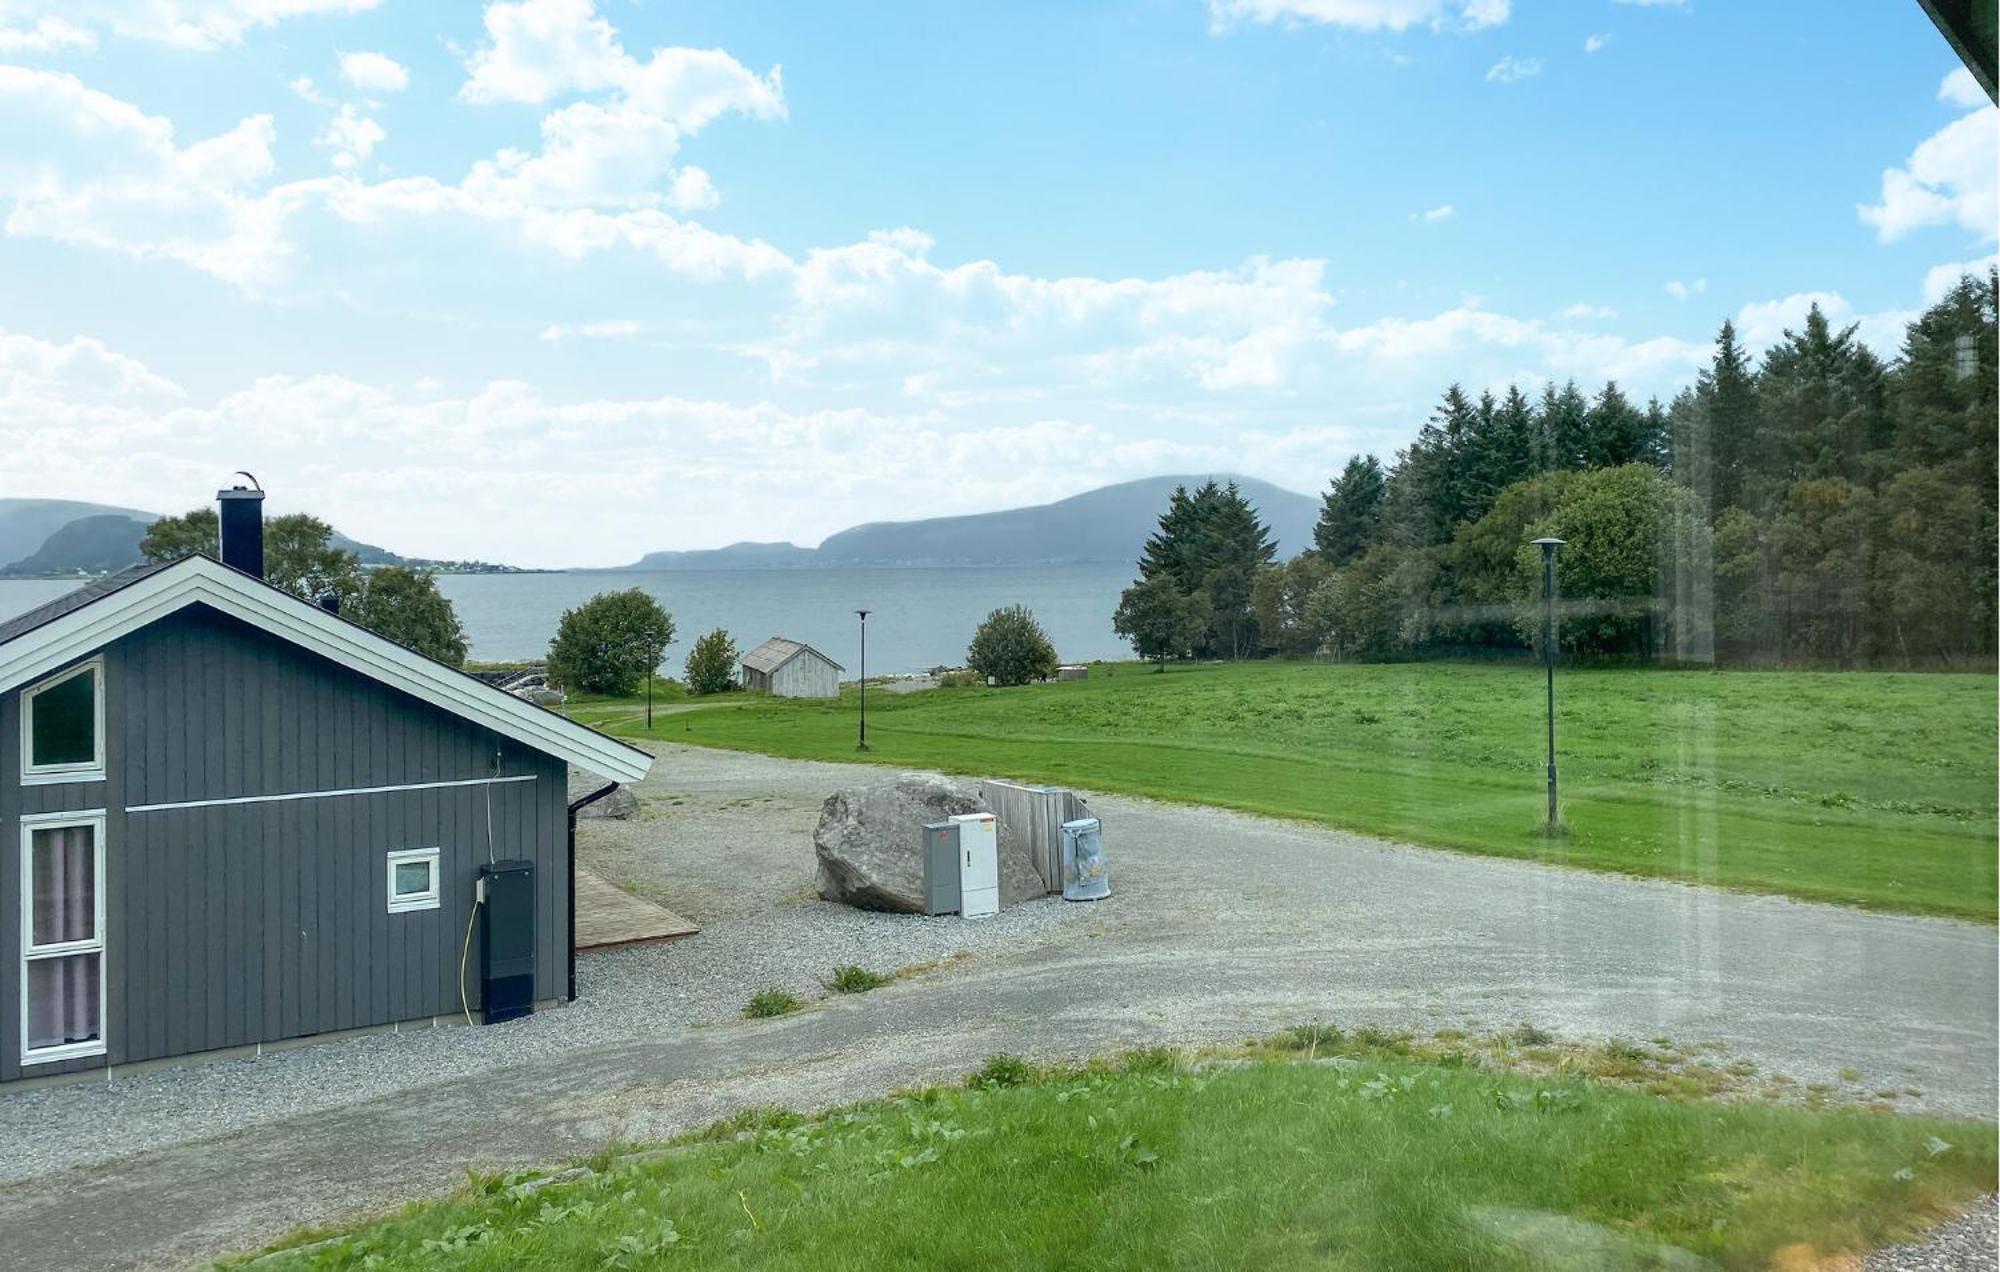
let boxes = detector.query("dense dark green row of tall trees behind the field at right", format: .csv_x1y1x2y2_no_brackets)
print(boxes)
1114,272,2000,666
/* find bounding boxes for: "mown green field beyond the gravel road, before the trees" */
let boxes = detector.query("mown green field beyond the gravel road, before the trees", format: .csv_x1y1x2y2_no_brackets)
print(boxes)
578,662,1996,922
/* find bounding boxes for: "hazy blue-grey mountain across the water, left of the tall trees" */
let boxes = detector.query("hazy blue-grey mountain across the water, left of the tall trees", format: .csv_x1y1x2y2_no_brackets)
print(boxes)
624,474,1320,570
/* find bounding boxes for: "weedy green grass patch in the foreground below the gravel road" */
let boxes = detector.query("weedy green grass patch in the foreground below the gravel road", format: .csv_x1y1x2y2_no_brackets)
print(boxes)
238,1030,1996,1270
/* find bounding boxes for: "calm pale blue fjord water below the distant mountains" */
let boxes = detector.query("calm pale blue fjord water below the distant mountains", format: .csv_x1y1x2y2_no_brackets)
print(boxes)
0,562,1134,676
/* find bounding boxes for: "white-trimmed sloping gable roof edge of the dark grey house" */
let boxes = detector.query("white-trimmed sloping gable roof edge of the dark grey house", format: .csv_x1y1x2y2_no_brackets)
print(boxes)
0,556,652,782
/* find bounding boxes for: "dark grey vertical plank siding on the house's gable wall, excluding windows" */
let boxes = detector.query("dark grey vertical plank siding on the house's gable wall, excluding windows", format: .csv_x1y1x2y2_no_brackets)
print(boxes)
0,606,570,1082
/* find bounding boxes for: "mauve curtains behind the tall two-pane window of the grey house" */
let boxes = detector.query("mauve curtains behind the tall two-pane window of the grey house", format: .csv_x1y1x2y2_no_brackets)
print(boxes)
28,826,104,1048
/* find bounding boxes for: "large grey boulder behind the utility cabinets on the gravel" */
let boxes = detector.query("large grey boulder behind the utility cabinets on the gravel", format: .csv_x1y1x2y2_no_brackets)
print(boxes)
812,772,1046,914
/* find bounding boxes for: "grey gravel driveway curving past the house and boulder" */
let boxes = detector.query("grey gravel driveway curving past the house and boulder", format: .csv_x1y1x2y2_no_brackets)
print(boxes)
0,748,2000,1266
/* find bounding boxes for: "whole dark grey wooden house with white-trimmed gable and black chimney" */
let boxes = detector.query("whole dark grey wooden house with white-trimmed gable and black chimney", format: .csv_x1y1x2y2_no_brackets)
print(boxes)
0,492,652,1084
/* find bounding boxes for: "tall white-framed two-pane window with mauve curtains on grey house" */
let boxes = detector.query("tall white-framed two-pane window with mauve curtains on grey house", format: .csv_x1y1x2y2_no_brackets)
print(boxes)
20,812,104,1064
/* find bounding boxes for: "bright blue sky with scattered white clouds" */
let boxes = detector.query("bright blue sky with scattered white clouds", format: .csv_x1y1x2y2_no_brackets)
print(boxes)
0,0,2000,564
